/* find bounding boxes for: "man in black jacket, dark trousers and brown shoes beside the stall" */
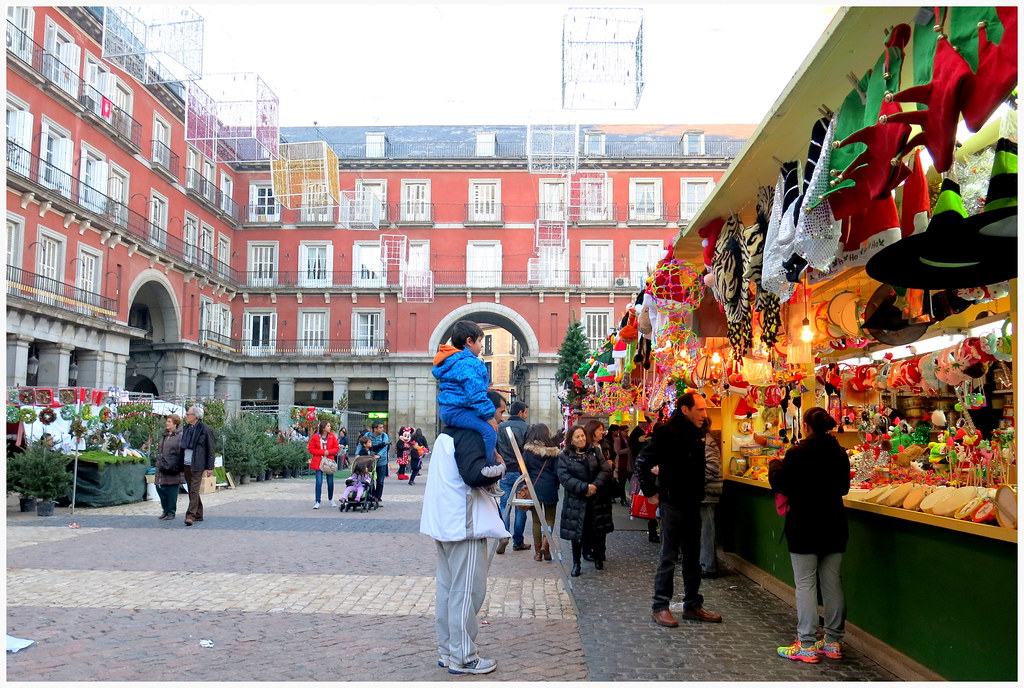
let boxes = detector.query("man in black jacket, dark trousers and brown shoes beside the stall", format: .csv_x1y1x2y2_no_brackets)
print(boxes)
636,392,722,628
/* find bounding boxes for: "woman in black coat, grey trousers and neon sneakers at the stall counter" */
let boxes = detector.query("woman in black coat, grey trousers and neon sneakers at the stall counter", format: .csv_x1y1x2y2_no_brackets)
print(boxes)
768,407,850,663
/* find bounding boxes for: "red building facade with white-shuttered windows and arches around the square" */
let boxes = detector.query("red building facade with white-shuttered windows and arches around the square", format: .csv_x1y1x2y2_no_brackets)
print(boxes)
6,7,754,428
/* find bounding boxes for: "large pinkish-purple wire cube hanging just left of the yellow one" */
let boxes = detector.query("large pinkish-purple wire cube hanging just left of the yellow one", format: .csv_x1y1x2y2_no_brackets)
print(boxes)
185,73,281,163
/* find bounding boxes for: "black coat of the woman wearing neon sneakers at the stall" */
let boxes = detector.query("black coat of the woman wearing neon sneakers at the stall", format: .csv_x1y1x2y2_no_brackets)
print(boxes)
768,434,850,555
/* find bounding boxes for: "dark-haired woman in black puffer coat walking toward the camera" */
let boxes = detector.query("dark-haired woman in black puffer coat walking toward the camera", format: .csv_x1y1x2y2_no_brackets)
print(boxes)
558,425,615,575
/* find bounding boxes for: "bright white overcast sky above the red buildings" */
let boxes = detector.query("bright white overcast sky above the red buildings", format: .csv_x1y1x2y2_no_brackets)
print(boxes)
193,2,837,127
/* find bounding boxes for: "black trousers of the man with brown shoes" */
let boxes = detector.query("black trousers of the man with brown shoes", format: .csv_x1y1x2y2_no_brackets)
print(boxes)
651,502,703,611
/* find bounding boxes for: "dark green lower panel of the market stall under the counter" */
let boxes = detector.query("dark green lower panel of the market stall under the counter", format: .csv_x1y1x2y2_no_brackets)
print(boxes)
719,480,1017,681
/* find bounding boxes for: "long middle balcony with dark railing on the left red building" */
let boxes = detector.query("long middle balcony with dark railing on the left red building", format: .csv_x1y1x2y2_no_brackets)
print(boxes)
7,140,239,284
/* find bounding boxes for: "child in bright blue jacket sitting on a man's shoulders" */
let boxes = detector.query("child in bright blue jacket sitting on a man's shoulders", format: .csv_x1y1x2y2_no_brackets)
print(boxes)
431,320,505,497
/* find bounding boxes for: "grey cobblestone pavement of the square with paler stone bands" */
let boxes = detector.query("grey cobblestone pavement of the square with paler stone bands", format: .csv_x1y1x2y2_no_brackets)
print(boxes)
6,470,894,681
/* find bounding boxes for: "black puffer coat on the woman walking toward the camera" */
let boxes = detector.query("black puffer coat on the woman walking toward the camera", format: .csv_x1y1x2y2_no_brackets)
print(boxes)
558,446,615,541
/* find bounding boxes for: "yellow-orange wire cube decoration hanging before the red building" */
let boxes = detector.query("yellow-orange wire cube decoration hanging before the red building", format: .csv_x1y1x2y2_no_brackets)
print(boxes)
270,141,341,209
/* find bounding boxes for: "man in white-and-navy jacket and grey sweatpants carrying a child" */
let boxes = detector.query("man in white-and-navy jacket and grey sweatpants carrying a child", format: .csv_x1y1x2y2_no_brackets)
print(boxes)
420,392,509,674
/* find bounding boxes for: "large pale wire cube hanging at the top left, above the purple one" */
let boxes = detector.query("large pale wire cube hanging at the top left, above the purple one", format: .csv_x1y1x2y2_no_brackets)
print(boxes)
101,5,204,84
